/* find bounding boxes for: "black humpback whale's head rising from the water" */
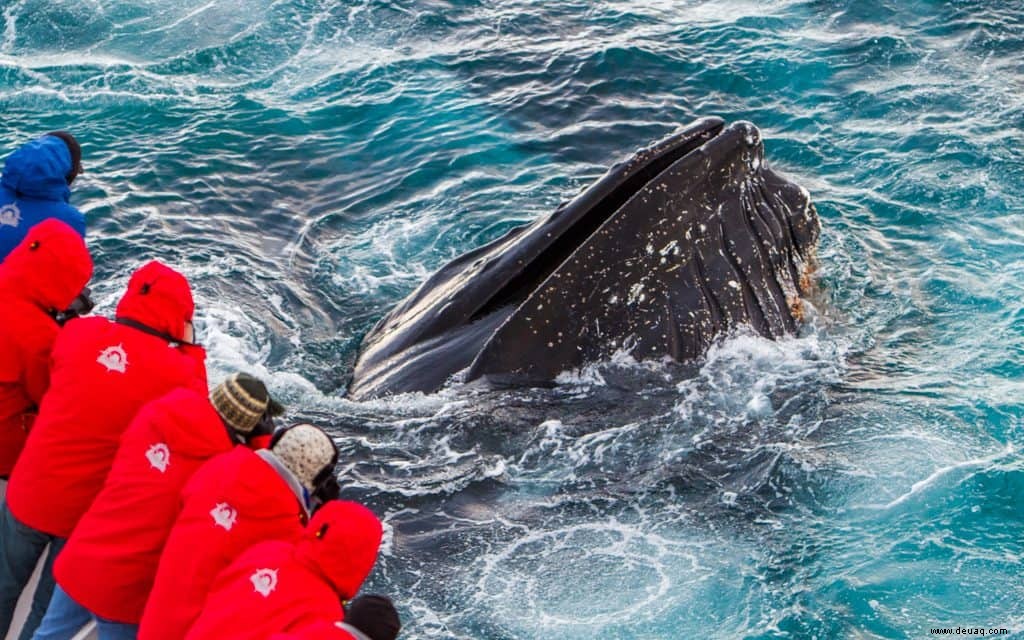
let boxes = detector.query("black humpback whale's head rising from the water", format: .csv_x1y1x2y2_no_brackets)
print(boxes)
348,118,819,399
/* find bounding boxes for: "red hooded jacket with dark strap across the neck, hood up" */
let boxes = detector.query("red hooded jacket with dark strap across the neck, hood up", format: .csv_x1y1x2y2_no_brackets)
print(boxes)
7,262,207,538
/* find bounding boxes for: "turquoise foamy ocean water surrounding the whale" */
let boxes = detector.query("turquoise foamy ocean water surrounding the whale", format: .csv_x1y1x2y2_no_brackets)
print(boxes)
0,0,1024,640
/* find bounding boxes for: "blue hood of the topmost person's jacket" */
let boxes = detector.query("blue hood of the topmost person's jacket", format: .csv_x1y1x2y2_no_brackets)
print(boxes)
0,135,72,202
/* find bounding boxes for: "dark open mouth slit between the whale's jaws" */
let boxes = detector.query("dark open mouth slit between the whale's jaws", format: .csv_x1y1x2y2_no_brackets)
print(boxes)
469,118,725,322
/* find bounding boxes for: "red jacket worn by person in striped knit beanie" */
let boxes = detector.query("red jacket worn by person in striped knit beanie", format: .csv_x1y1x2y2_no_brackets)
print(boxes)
53,389,234,624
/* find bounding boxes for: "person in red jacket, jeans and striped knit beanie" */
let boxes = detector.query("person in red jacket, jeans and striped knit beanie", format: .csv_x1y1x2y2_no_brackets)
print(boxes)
35,373,284,640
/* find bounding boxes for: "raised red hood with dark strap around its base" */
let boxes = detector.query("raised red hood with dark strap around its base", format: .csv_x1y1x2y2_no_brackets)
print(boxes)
117,260,196,340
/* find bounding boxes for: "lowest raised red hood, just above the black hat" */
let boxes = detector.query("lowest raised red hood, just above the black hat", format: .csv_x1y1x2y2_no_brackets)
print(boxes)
295,500,382,600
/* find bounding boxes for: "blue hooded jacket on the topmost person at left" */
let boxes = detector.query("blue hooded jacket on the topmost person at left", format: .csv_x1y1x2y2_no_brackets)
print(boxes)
0,135,85,261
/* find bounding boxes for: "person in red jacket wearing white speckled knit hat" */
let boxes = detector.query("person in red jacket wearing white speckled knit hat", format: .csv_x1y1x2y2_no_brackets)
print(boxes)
138,424,338,640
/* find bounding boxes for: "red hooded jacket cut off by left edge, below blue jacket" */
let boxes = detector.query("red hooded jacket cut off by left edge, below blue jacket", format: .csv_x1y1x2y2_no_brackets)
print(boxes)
0,220,92,477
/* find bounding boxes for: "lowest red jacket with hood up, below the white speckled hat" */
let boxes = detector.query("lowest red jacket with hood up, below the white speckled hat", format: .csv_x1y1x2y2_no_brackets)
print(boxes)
185,501,381,640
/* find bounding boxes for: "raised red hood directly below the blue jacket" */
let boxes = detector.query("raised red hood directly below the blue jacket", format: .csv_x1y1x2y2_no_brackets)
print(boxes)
0,218,92,311
